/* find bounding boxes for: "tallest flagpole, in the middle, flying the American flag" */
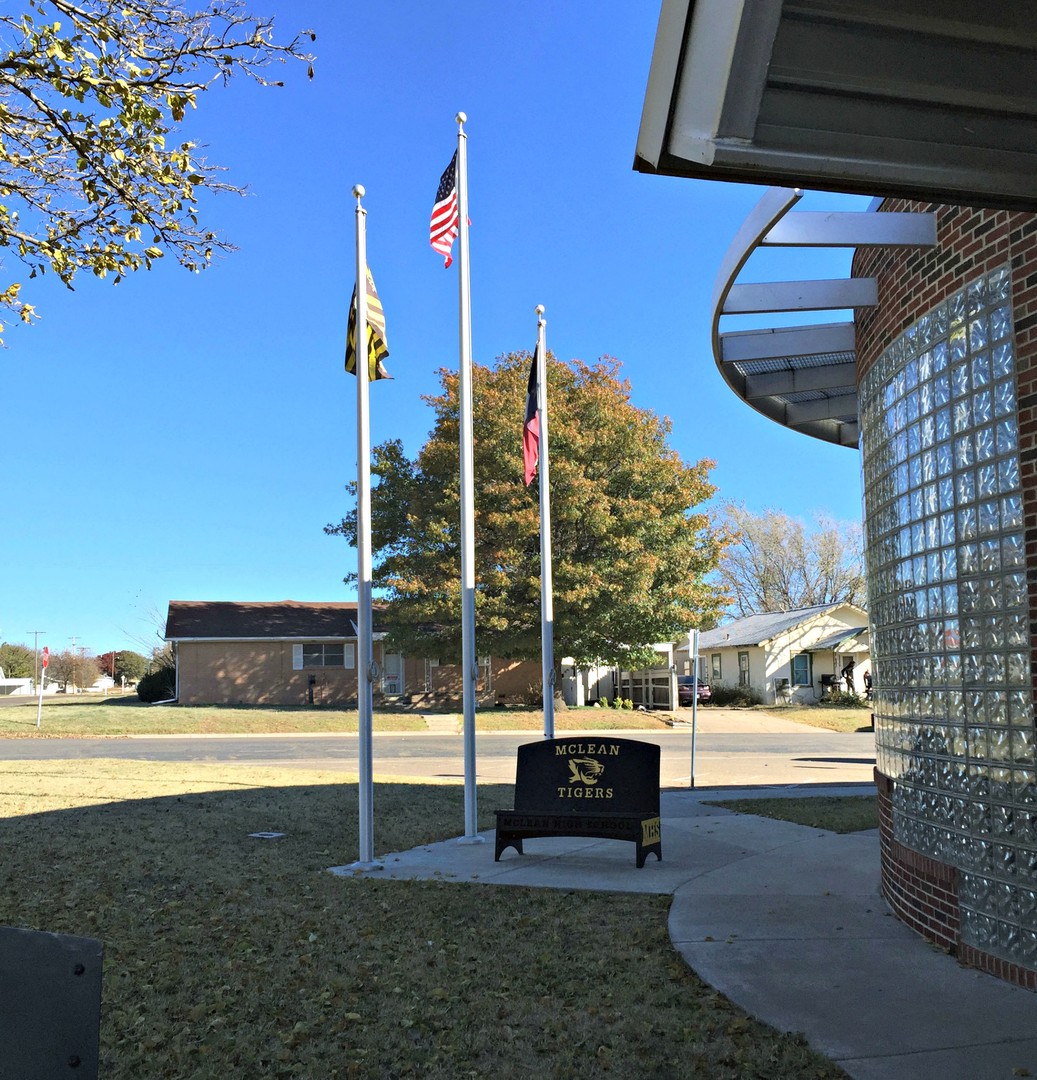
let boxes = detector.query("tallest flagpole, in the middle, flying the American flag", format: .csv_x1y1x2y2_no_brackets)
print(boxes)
456,112,482,843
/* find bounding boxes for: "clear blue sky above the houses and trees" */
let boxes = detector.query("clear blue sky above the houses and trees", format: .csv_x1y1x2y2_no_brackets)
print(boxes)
0,0,866,652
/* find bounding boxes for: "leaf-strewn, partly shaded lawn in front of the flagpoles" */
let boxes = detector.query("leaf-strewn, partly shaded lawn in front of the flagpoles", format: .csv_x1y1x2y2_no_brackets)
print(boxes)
0,760,845,1080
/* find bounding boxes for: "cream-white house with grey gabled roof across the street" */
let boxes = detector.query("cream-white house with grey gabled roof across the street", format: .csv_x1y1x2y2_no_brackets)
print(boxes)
675,604,871,705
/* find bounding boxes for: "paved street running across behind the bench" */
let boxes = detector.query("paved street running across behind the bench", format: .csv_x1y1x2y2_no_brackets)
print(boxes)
0,714,875,787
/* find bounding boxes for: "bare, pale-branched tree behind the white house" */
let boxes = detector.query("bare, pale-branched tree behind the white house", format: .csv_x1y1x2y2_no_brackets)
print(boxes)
720,504,866,616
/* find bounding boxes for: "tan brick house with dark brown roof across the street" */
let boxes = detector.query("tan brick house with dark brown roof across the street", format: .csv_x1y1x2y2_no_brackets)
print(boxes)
165,600,540,705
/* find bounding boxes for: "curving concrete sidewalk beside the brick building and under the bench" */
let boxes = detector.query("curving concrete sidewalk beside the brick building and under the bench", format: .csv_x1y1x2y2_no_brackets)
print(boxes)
337,784,1037,1080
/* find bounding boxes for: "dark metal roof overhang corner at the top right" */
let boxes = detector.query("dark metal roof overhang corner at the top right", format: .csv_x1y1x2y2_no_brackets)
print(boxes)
634,0,1037,210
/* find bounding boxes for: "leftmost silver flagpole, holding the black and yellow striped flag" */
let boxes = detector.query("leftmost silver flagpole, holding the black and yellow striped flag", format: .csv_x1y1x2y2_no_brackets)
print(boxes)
352,184,381,869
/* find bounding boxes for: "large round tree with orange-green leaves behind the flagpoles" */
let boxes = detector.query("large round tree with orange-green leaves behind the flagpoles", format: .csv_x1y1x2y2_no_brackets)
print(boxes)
326,353,723,667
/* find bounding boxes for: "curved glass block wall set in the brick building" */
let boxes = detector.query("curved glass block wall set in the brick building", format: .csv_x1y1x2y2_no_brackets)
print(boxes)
860,266,1037,967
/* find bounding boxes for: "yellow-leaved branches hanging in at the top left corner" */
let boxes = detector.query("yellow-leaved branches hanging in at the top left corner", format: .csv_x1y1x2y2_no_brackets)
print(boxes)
0,0,312,333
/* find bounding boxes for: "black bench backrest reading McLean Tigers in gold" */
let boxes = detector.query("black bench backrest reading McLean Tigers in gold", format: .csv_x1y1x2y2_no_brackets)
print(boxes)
515,735,659,816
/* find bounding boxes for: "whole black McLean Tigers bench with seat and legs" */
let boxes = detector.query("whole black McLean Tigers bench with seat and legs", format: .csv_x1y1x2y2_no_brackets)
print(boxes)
494,735,662,868
